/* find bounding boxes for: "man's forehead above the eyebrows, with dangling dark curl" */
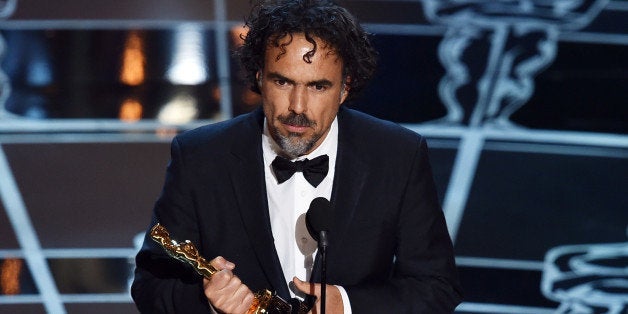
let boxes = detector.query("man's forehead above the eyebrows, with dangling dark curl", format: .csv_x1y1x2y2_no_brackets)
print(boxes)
264,33,343,72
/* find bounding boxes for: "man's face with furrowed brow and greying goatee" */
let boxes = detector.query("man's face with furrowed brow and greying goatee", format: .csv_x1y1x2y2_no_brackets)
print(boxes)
258,34,348,158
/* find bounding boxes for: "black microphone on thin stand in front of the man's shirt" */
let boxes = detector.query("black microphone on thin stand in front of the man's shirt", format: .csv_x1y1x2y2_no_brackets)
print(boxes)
305,197,331,314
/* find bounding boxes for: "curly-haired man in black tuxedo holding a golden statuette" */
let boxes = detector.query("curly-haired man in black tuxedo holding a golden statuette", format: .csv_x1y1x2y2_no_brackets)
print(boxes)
132,0,460,313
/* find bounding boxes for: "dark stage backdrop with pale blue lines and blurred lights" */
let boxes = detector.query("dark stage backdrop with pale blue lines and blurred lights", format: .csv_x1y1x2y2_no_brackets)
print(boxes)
0,0,628,314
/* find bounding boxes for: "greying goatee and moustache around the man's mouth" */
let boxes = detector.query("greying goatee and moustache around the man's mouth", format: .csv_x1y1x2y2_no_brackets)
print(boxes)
270,112,323,159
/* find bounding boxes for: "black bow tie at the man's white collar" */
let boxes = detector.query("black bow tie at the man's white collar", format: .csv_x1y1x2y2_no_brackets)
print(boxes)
271,155,329,187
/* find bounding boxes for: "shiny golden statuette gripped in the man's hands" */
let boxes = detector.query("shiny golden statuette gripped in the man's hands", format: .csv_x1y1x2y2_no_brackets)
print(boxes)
150,224,311,314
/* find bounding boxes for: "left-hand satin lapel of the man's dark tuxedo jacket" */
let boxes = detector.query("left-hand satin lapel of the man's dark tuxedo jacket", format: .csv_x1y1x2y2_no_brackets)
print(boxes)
229,109,290,298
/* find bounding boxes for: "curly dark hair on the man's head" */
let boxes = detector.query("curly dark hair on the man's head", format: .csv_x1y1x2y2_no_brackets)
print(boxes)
236,0,377,96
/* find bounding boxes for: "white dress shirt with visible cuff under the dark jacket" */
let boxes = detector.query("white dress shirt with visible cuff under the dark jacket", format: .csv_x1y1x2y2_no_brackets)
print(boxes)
262,119,351,313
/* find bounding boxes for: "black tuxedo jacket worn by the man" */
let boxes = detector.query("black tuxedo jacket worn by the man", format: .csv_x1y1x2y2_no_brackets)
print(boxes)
132,107,460,314
